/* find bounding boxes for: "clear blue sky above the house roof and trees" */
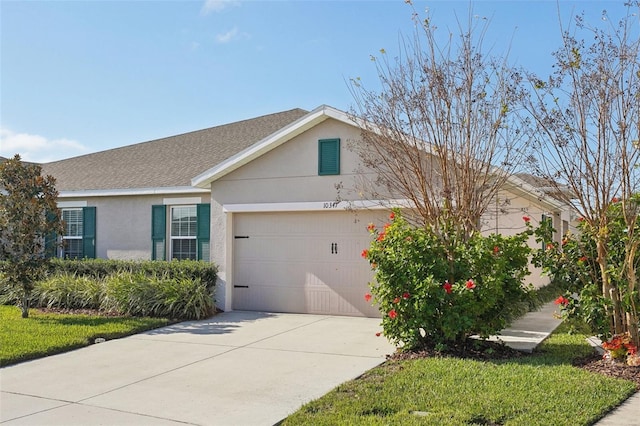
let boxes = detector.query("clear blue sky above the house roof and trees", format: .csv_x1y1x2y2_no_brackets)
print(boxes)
0,0,624,162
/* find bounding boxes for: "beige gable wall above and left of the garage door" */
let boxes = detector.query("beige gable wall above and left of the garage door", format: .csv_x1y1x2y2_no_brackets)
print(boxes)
211,119,376,310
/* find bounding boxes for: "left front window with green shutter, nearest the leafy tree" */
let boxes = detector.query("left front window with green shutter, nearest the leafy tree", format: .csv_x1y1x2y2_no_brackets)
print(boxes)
59,207,96,259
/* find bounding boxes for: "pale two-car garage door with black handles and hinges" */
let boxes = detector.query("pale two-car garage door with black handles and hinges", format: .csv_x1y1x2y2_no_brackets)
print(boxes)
233,211,386,317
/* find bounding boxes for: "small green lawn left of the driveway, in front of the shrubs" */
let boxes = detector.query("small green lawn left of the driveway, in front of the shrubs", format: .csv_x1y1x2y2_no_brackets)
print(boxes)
0,306,169,366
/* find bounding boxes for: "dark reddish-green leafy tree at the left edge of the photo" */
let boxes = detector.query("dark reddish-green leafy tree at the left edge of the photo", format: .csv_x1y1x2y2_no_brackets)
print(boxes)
0,155,63,318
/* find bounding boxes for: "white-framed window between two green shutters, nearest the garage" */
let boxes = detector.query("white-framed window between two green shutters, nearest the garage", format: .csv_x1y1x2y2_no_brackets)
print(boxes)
151,204,211,261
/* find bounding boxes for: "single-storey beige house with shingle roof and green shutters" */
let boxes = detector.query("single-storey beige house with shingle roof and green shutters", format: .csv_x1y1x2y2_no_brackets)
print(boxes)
37,106,570,316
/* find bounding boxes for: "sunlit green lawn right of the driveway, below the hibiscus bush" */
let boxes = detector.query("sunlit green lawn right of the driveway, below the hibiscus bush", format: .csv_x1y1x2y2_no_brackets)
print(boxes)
283,326,635,425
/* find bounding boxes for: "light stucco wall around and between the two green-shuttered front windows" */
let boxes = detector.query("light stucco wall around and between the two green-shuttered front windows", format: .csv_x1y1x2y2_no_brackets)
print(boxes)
59,193,209,260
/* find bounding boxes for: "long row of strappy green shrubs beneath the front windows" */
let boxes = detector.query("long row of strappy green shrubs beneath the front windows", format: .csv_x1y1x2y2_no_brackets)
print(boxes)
0,259,217,319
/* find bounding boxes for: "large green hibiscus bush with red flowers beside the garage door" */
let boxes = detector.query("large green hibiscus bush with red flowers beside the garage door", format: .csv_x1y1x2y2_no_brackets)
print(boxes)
362,212,533,349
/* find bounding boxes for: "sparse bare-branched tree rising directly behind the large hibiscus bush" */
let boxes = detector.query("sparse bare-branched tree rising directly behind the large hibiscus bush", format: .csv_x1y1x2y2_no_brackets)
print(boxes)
351,4,527,272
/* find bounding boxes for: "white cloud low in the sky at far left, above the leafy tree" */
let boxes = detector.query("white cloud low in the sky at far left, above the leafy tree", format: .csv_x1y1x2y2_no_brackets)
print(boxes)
0,128,89,163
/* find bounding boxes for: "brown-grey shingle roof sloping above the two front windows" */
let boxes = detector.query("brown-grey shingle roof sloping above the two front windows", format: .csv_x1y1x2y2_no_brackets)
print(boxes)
42,109,308,191
